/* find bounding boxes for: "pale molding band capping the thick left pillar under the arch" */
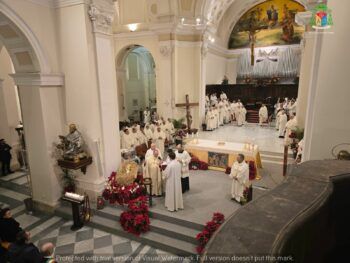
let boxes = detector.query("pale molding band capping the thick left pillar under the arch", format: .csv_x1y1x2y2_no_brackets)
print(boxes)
10,73,64,87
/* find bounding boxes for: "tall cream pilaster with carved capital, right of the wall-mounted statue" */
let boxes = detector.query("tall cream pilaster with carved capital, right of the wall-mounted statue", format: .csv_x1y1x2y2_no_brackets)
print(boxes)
89,0,121,178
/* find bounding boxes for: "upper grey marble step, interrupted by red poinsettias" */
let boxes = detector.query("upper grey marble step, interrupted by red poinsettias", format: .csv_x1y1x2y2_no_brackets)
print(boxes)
94,206,203,245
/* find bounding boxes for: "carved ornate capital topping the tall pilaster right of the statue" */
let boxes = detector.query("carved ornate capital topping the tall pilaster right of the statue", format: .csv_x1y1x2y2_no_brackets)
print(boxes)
88,0,116,35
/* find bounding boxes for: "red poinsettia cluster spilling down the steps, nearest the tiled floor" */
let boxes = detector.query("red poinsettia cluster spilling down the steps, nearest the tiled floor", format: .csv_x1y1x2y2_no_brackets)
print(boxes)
120,196,150,236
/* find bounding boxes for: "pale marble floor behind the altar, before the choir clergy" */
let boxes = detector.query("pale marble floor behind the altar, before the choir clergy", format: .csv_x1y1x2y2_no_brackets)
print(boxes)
199,123,284,153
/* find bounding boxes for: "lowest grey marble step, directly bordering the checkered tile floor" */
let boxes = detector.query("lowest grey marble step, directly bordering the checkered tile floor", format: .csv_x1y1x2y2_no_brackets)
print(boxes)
55,206,196,257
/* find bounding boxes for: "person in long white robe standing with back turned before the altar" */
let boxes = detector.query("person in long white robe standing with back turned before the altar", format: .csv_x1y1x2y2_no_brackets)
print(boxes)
163,152,184,212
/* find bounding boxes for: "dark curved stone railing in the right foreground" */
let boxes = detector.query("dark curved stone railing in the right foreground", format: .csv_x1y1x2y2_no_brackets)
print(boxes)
202,160,350,263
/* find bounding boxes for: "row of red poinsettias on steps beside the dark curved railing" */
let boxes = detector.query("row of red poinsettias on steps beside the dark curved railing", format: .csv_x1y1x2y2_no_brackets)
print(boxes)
196,213,225,254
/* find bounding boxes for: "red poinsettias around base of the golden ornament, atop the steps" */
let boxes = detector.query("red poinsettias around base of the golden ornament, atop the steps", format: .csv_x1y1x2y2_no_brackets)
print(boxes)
102,172,146,205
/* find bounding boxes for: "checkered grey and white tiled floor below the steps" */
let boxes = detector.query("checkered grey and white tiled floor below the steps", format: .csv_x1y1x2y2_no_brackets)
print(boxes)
0,172,188,262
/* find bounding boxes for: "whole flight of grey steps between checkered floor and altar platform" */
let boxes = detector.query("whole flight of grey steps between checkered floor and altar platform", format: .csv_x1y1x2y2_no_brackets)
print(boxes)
55,205,197,256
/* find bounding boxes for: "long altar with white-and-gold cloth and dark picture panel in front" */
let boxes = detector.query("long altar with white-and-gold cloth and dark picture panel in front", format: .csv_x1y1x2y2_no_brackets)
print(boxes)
185,138,262,176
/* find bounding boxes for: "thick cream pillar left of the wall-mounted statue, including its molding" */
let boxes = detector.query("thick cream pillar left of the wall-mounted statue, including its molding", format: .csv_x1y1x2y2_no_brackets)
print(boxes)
11,73,64,209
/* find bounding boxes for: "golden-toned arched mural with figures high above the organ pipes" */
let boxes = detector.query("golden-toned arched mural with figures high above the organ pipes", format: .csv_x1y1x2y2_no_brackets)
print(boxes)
228,0,305,49
